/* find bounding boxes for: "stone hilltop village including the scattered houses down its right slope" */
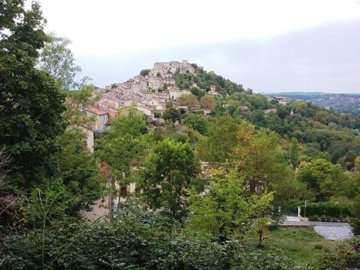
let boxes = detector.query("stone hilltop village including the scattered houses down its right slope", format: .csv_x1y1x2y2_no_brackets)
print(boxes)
84,60,286,151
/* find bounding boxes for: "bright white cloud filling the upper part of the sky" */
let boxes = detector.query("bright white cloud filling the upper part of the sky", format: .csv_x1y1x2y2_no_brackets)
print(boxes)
36,0,360,55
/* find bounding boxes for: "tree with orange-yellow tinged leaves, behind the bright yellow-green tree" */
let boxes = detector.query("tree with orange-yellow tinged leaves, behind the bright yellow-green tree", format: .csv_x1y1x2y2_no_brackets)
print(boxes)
232,122,296,209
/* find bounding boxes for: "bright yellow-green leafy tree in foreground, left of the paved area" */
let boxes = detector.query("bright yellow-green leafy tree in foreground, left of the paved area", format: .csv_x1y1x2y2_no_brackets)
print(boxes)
187,170,273,242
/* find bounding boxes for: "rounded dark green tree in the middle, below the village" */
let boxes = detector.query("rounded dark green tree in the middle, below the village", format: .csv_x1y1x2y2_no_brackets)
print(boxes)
142,139,199,220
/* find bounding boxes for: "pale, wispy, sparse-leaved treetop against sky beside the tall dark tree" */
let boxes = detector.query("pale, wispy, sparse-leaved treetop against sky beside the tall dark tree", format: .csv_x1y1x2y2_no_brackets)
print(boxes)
38,34,81,90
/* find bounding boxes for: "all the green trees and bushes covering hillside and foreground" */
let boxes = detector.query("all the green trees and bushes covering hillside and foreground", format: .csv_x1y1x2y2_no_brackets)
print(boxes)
0,0,360,270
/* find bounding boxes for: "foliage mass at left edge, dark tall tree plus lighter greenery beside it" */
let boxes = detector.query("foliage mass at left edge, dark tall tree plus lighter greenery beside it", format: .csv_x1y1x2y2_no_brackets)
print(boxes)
0,1,102,227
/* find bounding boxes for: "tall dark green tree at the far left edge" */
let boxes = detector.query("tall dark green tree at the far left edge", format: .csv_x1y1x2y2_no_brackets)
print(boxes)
0,0,65,188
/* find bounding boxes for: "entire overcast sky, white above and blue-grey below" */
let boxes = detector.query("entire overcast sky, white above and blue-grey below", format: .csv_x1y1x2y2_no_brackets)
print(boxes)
29,0,360,93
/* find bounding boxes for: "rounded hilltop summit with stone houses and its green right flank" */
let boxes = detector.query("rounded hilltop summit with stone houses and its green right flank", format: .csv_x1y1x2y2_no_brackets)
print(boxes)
89,61,243,119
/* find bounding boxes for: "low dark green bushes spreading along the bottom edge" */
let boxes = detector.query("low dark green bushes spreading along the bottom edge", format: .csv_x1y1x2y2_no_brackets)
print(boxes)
0,211,310,270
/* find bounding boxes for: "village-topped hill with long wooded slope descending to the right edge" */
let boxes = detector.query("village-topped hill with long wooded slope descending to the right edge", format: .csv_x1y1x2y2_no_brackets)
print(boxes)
88,61,360,170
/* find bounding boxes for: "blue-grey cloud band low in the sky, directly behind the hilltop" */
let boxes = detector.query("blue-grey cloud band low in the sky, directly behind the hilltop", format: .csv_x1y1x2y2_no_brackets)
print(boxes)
77,20,360,92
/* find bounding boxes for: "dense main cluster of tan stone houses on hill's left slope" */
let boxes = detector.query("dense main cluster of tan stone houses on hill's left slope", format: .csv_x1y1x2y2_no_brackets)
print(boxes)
86,60,220,132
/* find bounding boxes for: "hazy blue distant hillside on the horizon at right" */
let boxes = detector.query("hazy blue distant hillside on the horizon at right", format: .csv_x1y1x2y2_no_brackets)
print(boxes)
265,92,360,112
